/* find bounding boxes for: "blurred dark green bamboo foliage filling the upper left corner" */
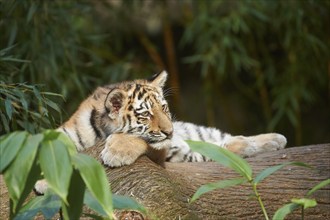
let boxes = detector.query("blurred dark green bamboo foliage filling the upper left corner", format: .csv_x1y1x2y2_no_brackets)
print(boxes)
0,0,143,118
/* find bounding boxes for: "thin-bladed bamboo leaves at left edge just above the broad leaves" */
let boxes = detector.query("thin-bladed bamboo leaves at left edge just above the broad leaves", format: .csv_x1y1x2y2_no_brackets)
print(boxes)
0,77,61,134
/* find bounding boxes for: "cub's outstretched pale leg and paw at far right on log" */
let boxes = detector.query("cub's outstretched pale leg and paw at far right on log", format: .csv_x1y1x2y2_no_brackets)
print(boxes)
225,133,287,157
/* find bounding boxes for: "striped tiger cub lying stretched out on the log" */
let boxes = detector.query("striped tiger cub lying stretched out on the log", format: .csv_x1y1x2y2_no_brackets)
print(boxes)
36,71,286,191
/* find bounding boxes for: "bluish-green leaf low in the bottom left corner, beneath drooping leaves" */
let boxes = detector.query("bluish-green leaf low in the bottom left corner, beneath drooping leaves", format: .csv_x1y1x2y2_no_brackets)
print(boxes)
14,193,61,220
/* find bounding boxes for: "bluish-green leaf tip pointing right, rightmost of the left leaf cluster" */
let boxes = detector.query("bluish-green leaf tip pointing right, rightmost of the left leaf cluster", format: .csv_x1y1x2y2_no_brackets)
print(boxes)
112,194,146,213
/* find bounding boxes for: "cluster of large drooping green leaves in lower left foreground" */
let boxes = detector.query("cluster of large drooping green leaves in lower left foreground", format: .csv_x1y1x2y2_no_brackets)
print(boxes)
0,130,145,219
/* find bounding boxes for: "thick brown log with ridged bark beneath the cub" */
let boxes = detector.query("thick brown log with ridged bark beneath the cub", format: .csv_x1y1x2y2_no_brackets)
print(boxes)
86,144,330,219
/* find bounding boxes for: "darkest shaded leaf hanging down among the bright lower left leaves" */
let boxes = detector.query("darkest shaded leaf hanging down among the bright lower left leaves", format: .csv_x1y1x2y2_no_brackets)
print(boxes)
62,170,85,219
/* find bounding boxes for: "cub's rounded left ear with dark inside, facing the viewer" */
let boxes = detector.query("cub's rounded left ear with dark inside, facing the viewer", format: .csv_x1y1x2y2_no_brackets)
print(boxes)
104,89,126,119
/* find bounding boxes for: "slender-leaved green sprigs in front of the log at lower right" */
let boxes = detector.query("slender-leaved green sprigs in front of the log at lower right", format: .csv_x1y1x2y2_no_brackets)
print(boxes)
187,141,330,220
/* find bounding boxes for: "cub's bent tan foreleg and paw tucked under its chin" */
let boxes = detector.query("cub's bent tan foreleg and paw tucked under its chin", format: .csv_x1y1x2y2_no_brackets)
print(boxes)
101,134,148,167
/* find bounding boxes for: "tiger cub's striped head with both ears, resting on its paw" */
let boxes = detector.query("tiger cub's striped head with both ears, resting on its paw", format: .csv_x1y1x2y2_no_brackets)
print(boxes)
105,71,173,150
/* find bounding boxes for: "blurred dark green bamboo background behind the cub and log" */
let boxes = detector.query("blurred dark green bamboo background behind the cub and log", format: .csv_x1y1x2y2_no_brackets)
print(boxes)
0,0,330,146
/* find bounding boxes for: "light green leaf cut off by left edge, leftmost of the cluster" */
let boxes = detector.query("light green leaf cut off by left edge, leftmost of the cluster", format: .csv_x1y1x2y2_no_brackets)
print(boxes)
0,131,29,173
